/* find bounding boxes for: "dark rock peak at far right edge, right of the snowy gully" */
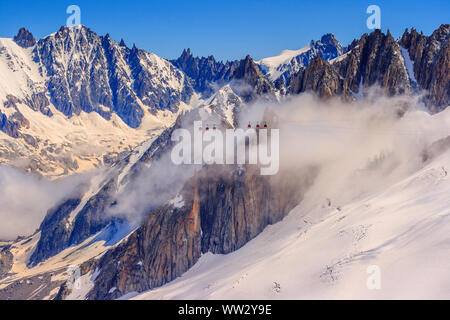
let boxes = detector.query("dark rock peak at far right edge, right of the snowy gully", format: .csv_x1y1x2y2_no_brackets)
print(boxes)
399,24,450,111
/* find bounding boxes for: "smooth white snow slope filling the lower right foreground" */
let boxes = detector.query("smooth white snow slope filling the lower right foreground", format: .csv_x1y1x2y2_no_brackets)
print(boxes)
134,148,450,299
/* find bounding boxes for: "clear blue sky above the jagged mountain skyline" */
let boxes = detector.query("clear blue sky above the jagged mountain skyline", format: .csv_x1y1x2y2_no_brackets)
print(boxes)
0,0,450,60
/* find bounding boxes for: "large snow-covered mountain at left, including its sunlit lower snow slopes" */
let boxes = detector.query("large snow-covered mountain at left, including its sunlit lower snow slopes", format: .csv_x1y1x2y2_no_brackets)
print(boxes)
0,27,194,176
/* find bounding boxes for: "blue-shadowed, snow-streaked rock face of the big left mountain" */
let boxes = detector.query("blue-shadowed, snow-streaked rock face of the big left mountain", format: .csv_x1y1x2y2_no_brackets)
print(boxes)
34,27,193,128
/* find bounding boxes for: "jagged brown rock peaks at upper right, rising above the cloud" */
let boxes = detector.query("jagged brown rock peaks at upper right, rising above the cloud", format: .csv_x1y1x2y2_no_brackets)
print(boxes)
289,24,450,106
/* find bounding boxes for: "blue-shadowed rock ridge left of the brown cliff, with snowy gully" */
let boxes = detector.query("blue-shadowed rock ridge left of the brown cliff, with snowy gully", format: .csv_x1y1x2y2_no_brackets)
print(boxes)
28,116,180,267
